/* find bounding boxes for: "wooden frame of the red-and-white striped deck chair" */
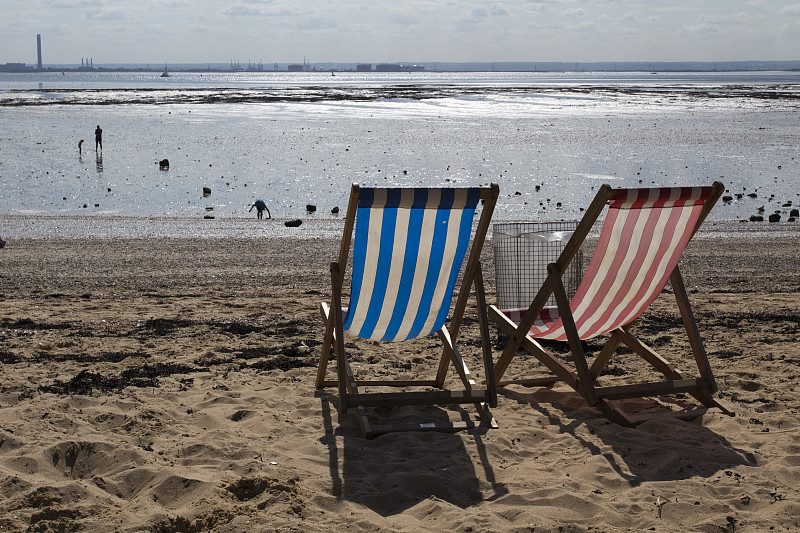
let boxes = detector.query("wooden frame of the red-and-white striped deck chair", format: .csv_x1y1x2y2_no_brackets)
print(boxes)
489,182,733,427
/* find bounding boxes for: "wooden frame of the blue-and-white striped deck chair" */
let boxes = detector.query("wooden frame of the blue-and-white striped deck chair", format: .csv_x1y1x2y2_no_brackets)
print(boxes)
316,184,499,438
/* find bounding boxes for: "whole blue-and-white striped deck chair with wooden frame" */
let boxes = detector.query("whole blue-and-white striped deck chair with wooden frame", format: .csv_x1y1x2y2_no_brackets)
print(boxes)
316,184,499,437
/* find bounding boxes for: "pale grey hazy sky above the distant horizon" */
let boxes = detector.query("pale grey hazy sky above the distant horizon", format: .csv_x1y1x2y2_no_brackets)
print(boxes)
0,0,800,67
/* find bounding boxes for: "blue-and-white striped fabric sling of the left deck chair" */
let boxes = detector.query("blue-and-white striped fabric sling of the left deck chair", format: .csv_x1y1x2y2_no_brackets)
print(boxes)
343,188,480,341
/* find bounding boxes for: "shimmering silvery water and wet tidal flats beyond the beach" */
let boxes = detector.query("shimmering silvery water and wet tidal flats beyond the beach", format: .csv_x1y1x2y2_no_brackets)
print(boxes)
0,71,800,237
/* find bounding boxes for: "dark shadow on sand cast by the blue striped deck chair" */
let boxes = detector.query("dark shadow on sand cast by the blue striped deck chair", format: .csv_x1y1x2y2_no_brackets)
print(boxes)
317,391,508,517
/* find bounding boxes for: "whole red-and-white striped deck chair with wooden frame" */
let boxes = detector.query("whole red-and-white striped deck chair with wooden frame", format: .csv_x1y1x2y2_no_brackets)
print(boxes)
489,182,733,427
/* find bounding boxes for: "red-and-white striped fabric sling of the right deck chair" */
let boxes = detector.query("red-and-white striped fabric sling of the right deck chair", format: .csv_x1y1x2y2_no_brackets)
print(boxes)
503,187,714,340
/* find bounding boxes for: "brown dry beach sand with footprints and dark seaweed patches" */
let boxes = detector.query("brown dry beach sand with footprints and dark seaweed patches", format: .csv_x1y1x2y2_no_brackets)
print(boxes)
0,225,800,532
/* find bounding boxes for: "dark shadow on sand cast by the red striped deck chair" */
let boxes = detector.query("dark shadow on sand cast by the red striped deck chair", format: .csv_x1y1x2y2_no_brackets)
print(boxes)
498,387,757,486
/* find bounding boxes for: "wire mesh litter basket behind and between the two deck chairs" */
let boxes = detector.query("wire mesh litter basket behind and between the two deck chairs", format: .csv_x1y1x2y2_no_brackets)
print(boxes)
492,221,583,309
